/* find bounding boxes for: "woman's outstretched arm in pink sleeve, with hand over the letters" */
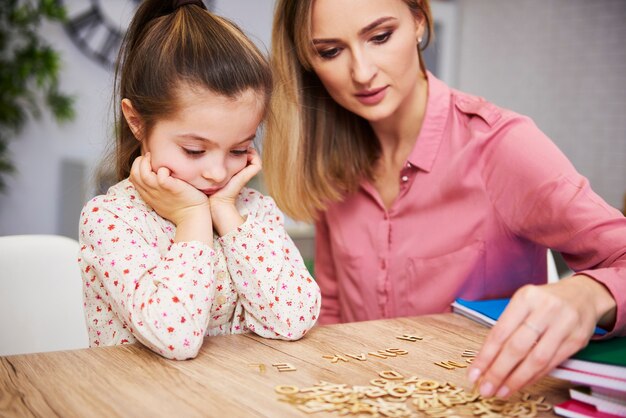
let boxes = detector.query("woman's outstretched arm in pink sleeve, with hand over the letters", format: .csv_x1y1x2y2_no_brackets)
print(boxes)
469,112,626,396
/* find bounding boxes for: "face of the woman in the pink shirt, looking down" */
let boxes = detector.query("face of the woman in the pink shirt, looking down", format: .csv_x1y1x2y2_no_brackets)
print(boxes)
311,0,424,122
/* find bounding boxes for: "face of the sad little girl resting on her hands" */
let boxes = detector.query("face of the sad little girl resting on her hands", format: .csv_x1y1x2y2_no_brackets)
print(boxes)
125,87,264,195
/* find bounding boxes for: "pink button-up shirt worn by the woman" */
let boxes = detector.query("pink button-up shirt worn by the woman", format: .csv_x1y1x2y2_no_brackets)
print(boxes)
315,70,626,335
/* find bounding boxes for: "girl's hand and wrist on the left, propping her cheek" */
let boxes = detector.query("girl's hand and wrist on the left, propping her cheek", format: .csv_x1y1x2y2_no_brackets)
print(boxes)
130,153,213,245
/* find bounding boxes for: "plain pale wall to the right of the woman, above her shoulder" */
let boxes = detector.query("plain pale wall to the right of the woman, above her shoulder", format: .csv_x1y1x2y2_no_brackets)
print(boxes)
457,0,626,209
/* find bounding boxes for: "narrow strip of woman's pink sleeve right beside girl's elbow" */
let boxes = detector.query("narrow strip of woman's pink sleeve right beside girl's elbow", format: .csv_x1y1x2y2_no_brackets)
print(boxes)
315,213,341,325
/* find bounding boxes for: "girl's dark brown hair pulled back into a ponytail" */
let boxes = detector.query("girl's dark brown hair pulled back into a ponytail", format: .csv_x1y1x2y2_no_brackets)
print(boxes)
111,0,272,181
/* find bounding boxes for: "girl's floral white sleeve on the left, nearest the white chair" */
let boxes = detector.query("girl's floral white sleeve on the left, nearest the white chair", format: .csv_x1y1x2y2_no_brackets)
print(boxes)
80,198,215,360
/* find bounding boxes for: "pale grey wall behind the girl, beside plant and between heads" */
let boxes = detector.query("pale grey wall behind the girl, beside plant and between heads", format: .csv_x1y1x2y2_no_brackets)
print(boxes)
0,0,274,235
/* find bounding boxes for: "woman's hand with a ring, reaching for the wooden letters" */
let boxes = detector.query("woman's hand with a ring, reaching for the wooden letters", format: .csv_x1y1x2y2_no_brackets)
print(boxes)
469,275,616,398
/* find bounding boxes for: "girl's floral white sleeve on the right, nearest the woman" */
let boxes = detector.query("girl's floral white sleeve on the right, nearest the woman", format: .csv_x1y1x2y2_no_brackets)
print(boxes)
220,192,321,340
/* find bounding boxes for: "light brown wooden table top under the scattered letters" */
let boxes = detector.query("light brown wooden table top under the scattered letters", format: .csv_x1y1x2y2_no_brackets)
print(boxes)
0,314,570,418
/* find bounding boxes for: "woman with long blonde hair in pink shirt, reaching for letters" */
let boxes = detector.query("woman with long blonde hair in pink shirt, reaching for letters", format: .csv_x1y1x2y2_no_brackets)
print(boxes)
264,0,626,397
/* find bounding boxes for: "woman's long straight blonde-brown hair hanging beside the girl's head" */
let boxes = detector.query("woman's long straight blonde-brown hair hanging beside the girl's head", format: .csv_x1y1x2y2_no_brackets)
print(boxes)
263,0,433,221
